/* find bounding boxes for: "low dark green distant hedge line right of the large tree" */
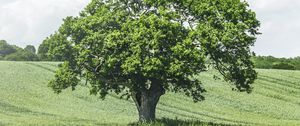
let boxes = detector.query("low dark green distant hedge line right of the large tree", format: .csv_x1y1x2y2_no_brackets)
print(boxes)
252,56,300,70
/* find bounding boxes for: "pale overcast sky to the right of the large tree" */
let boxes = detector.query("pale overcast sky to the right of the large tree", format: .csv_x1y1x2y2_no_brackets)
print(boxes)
248,0,300,57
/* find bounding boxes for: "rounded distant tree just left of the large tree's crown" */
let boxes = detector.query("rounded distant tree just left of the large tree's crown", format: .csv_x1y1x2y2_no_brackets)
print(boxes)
38,33,74,61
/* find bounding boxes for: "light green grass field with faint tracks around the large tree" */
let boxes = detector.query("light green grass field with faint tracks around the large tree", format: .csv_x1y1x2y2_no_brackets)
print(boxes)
0,62,300,125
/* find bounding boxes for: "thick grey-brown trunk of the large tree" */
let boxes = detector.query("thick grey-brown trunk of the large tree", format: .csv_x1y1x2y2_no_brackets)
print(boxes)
132,81,165,122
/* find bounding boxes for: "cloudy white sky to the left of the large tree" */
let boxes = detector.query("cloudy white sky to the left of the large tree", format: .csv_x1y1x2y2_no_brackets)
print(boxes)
0,0,89,47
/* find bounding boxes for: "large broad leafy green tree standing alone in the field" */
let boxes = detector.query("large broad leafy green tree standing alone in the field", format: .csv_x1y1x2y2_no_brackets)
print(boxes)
49,0,259,121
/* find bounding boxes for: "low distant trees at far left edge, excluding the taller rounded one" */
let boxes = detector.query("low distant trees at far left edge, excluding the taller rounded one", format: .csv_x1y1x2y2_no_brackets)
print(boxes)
0,40,39,61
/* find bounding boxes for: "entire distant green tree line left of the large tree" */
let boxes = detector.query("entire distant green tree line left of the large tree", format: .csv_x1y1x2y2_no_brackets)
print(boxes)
0,33,72,61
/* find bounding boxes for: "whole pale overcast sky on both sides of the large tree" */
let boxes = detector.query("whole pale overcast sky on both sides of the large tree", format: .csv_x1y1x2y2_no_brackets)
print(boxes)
0,0,300,57
